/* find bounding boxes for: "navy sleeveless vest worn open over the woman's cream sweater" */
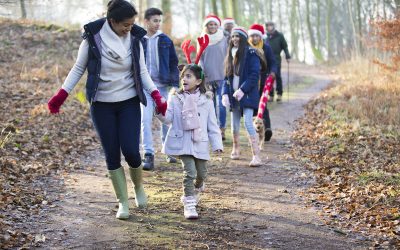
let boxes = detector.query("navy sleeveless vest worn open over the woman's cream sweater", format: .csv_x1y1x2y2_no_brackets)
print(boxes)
82,18,147,105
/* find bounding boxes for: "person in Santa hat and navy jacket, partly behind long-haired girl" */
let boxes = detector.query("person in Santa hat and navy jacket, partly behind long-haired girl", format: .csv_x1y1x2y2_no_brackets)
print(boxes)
248,24,277,141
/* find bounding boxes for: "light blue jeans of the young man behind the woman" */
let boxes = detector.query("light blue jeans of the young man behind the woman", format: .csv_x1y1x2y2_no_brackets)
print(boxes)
140,86,169,155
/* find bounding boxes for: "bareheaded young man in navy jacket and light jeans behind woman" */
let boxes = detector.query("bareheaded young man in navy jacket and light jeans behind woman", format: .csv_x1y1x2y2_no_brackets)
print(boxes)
142,8,179,170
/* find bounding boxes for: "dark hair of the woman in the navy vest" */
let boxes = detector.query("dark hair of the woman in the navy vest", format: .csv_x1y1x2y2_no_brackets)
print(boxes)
107,0,137,23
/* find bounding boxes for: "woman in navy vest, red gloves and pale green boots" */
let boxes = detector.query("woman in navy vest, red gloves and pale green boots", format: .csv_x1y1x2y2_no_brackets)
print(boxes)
48,0,167,219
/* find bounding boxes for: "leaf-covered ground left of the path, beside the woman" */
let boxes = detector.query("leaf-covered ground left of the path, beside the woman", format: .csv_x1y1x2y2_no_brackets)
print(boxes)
0,19,97,249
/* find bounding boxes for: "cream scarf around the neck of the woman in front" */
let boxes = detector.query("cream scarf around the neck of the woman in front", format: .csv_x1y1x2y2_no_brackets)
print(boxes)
100,21,131,62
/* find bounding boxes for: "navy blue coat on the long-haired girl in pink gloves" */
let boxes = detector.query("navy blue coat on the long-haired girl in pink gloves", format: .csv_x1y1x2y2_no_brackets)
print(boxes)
222,46,260,109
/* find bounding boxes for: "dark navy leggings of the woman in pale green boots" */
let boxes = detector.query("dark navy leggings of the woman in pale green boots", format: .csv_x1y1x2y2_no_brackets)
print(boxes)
90,97,142,170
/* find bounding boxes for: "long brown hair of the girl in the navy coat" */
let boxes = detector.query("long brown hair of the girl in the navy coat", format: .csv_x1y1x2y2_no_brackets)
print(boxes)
224,34,248,76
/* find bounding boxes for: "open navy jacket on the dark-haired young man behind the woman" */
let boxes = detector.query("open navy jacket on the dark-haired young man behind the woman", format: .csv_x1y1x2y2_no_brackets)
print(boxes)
141,34,179,88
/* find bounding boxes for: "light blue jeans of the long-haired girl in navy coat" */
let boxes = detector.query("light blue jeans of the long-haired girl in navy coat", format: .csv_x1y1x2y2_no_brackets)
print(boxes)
231,101,256,136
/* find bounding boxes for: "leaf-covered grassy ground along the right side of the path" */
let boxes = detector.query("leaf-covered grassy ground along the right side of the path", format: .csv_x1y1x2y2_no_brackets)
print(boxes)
293,15,400,249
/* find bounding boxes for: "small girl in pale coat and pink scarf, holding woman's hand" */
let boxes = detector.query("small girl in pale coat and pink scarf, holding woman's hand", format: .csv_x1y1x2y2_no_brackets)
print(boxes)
157,64,223,219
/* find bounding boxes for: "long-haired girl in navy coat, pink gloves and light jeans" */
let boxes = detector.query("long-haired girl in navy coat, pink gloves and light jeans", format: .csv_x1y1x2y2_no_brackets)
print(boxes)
222,27,262,166
